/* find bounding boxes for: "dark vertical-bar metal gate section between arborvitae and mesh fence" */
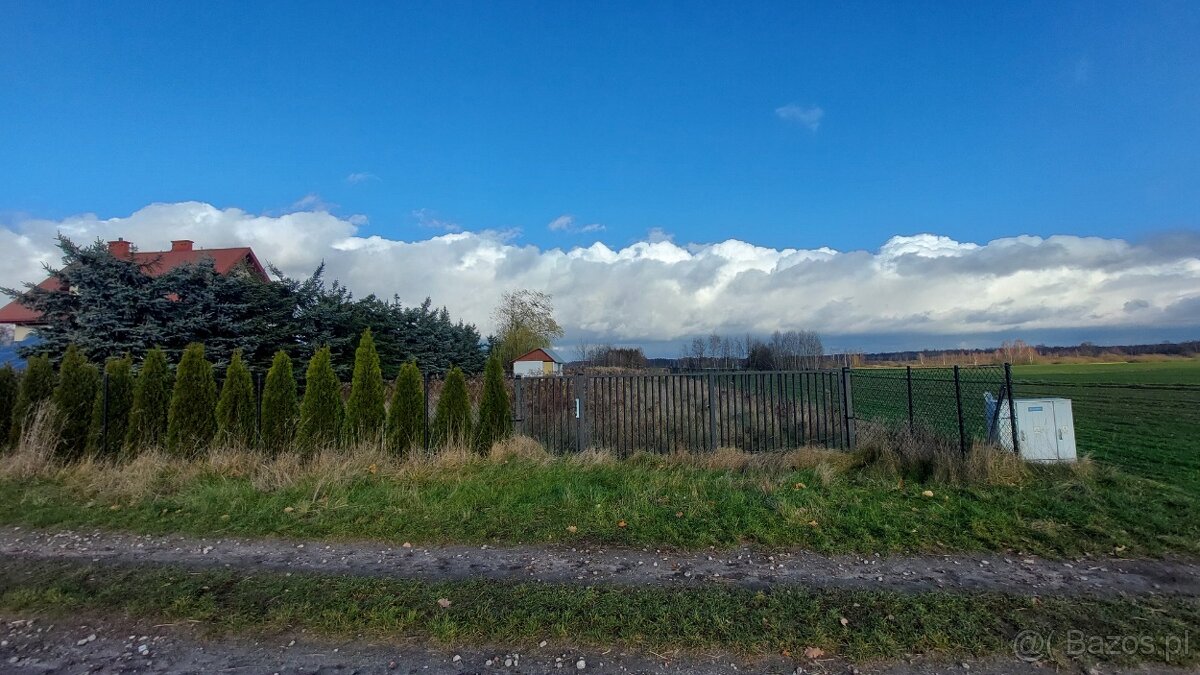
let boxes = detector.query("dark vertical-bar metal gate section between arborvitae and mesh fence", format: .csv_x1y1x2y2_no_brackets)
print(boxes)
514,370,853,454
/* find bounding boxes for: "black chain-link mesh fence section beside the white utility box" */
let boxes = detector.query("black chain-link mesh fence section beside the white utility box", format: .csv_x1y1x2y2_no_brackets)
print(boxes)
852,364,1016,453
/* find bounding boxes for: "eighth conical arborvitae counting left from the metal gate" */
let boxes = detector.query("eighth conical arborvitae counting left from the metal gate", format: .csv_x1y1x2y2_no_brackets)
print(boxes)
167,342,217,455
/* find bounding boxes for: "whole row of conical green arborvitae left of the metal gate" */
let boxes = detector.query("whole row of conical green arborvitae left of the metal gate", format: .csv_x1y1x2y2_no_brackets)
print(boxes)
0,329,512,460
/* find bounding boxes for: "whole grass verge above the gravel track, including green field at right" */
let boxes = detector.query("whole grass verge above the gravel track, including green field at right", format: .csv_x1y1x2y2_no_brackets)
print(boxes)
0,362,1200,556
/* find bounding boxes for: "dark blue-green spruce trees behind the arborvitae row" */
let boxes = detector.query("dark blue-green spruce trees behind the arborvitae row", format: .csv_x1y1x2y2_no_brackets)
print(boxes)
2,235,487,378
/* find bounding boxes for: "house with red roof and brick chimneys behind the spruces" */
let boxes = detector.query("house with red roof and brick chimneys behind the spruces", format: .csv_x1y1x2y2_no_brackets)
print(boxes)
0,239,270,342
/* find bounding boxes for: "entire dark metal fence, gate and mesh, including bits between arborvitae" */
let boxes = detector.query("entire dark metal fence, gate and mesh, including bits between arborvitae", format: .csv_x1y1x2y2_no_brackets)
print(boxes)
88,364,1016,454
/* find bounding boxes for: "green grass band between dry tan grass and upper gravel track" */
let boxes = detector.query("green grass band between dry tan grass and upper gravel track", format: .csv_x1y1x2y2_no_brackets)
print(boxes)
0,455,1200,556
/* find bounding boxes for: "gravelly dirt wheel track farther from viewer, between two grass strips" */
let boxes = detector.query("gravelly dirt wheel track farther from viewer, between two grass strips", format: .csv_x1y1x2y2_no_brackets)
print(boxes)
0,527,1200,597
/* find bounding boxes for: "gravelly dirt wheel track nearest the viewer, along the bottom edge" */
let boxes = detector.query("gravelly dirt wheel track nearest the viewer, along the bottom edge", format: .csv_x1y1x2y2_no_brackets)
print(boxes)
9,613,1189,675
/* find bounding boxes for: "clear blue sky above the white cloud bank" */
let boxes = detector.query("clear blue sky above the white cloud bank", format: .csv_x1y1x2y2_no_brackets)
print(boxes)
0,2,1200,250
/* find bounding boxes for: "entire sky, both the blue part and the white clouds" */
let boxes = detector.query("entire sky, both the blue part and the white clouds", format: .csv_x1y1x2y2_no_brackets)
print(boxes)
0,1,1200,353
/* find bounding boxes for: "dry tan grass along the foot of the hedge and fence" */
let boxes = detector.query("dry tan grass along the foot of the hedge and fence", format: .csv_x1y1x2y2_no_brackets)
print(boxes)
0,415,1051,501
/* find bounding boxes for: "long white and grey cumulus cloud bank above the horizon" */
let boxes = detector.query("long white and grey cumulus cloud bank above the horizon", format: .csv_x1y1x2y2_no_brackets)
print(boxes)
0,202,1200,342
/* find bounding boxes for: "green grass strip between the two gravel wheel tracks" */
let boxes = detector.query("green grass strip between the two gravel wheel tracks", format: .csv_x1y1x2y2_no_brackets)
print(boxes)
0,560,1200,665
